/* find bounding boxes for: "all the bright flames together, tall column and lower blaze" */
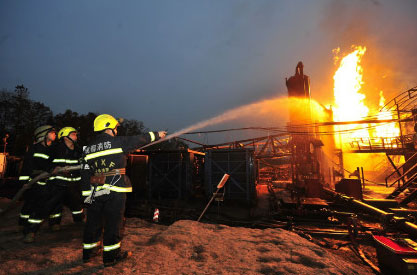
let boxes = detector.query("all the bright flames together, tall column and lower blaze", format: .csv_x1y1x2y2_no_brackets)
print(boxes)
333,46,400,175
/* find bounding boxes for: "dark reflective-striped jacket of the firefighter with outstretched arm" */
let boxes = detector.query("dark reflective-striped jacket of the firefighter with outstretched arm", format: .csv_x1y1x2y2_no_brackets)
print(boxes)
81,132,159,196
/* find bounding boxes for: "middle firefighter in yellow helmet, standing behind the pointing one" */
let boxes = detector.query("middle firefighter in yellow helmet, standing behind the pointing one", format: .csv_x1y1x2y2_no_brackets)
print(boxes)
47,127,84,231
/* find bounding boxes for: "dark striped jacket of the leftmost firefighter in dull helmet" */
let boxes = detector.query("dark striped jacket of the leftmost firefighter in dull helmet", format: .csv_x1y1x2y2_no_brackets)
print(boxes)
19,142,52,185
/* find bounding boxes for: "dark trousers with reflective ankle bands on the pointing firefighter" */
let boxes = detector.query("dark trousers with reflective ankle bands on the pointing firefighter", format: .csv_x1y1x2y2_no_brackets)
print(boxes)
83,191,126,262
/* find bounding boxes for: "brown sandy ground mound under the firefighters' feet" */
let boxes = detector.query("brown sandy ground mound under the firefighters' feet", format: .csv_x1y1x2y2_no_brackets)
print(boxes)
0,198,374,274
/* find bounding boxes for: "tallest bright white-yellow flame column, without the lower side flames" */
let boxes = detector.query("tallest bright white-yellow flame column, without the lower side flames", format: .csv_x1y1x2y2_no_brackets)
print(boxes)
333,46,369,146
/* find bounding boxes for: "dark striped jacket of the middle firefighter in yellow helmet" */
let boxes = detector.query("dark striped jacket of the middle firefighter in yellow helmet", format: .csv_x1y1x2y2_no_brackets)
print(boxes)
49,141,81,186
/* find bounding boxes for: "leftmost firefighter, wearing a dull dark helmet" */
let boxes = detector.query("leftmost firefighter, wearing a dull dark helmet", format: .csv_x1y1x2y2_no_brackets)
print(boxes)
19,125,56,237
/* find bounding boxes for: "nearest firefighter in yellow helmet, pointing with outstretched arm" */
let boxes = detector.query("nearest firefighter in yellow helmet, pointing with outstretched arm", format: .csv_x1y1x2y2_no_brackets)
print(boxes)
81,114,166,266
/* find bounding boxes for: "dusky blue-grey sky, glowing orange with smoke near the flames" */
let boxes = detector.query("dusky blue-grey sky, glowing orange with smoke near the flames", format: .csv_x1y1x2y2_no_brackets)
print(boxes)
0,0,417,144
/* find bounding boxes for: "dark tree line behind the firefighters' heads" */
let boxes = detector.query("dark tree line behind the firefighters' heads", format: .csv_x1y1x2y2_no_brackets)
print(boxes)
0,85,187,155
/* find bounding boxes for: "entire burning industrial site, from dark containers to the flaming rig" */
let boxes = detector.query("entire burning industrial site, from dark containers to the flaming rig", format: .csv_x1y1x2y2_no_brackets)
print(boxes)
2,47,417,272
